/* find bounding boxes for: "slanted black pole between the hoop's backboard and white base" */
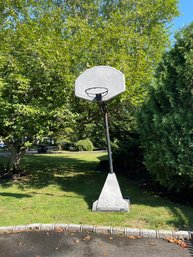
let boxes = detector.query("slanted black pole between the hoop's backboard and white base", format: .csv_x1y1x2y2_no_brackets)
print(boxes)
101,102,114,174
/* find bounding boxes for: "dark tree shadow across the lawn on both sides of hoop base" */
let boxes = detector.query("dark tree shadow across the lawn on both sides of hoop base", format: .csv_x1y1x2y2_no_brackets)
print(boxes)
1,152,193,230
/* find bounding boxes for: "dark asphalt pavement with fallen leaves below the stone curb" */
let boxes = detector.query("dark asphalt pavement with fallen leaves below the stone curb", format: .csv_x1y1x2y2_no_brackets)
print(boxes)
0,231,193,257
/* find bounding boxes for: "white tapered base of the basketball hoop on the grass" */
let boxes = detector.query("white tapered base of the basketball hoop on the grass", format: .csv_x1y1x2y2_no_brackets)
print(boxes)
92,173,129,212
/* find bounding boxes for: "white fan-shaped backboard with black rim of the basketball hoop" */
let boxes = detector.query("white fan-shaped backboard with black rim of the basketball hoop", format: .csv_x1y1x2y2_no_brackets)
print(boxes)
75,66,125,101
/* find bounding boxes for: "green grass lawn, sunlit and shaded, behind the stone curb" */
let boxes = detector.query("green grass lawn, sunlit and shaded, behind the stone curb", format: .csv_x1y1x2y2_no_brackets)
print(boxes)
0,152,193,229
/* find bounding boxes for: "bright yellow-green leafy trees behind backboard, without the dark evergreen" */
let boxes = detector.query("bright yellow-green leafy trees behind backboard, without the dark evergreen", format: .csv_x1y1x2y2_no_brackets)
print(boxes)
0,0,178,170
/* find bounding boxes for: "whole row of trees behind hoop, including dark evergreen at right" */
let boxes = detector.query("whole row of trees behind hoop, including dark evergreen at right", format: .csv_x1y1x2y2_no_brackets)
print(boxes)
0,0,192,194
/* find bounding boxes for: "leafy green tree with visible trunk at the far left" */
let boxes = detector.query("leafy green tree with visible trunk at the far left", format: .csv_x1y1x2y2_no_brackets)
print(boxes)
0,1,72,169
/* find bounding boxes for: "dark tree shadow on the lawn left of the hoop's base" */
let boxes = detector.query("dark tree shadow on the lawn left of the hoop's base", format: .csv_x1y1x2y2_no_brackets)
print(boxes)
19,152,107,208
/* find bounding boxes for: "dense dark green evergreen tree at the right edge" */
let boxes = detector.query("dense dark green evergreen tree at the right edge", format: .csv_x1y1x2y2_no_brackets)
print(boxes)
139,23,193,190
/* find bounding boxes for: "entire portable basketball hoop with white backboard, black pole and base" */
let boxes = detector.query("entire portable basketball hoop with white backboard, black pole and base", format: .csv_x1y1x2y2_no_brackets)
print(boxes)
75,66,129,212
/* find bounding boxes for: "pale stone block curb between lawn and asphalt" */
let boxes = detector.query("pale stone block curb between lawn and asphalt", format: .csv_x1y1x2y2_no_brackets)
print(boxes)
0,223,193,240
